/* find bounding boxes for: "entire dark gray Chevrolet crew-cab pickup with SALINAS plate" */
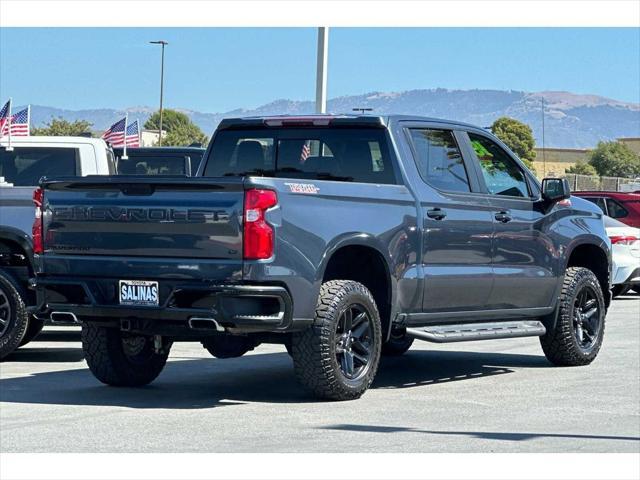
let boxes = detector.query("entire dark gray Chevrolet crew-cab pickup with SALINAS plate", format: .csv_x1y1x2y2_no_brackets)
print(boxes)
32,116,610,400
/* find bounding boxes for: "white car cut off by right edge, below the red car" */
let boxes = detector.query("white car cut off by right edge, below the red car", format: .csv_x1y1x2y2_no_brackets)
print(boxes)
604,217,640,297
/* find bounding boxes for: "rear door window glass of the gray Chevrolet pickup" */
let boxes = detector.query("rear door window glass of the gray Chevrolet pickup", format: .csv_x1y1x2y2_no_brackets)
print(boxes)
410,128,471,192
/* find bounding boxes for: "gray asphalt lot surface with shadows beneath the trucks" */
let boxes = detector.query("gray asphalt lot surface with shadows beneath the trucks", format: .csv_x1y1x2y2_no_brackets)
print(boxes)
0,295,640,452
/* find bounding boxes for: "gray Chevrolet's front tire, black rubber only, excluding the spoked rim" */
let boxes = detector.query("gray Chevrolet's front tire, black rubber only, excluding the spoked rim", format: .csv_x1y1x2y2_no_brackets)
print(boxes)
540,267,606,366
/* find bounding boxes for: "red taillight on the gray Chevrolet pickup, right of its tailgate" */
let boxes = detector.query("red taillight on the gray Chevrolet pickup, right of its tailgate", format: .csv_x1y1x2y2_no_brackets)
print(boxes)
243,189,278,260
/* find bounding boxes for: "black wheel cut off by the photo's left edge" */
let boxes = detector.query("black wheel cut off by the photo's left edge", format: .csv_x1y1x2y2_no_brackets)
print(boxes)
0,270,29,360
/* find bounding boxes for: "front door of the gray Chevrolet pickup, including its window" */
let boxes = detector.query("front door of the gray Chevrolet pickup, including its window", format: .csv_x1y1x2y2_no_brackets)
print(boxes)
468,132,557,309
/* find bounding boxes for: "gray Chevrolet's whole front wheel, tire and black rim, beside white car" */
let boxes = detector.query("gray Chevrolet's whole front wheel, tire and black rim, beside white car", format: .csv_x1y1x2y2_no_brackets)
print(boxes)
540,267,606,366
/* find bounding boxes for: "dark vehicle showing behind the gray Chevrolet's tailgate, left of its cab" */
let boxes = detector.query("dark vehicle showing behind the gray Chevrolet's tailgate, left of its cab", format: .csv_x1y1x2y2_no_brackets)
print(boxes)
113,147,204,177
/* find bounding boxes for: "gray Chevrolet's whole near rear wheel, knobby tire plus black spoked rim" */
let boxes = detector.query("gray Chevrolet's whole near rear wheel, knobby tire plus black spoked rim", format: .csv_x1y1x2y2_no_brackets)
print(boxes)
291,280,382,400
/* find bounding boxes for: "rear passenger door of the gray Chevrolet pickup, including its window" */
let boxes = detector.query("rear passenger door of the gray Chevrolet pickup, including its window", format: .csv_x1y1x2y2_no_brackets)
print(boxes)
405,124,493,314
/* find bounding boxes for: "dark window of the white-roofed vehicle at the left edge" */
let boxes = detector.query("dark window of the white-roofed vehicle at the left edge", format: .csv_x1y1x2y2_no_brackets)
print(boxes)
0,147,79,187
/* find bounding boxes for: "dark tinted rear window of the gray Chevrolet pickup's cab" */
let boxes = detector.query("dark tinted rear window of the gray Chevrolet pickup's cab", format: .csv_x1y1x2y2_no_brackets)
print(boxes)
204,128,396,184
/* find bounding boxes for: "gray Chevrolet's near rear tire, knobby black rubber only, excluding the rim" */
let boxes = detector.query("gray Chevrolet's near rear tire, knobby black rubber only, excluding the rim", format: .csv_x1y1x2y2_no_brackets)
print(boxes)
291,280,382,400
